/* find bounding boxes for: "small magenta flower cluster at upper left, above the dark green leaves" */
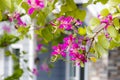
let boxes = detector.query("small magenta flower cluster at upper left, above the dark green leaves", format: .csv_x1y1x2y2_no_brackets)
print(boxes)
9,12,26,26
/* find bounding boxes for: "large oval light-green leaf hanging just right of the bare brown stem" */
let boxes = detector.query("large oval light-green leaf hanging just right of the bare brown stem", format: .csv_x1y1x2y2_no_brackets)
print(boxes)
98,34,110,49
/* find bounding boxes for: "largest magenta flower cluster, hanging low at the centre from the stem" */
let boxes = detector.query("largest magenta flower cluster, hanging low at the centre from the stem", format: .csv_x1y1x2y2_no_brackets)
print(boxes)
52,35,89,65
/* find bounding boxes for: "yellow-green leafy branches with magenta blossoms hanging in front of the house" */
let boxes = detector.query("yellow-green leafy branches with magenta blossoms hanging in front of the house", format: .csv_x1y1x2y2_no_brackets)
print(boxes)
0,0,120,80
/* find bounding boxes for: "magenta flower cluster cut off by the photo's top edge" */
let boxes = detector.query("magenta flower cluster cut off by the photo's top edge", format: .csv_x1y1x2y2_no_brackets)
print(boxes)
27,0,45,15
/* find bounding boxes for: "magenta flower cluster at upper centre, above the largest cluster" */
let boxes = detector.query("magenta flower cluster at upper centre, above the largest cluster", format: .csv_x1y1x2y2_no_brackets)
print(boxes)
51,16,82,30
